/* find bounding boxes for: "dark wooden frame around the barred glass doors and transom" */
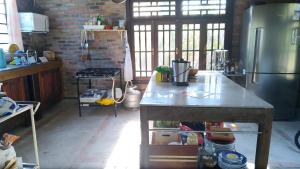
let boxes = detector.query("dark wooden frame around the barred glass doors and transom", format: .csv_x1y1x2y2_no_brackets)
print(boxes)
126,0,235,83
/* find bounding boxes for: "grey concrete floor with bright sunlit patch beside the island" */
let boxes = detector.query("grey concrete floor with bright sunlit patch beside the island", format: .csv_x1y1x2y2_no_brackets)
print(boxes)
11,100,300,169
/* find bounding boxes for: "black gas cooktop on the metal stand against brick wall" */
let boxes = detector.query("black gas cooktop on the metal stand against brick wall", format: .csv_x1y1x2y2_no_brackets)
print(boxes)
76,68,120,77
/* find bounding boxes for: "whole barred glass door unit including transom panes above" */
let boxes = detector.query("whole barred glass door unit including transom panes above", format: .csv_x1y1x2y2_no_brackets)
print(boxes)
129,0,233,80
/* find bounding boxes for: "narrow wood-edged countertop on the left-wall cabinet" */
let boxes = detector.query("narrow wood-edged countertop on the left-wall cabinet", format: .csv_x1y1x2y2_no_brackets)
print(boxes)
0,60,62,81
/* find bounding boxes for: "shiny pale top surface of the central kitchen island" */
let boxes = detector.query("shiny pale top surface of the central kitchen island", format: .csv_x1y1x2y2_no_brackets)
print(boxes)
140,71,273,109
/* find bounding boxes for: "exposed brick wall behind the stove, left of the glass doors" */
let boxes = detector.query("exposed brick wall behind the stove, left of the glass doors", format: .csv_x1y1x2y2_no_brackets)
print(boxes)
36,0,126,97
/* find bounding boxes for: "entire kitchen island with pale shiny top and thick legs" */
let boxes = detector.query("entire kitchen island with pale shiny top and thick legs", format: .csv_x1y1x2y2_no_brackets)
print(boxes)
140,71,273,169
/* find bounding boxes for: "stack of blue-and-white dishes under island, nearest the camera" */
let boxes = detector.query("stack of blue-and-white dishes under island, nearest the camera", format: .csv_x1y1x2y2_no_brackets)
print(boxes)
218,151,247,169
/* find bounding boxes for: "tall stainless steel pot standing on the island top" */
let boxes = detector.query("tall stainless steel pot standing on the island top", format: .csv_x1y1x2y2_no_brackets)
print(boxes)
172,59,191,86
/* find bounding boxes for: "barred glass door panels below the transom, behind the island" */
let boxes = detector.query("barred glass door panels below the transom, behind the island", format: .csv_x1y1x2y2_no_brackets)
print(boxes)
134,23,225,77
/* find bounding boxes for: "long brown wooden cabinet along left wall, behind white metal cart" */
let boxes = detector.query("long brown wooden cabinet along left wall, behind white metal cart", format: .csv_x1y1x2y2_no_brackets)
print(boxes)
0,61,63,129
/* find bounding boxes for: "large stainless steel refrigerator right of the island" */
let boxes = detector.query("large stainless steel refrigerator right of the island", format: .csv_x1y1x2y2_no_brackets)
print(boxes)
240,3,300,120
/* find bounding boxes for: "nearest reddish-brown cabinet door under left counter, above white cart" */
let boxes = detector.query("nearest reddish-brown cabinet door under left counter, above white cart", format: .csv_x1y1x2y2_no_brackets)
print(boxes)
2,77,27,101
